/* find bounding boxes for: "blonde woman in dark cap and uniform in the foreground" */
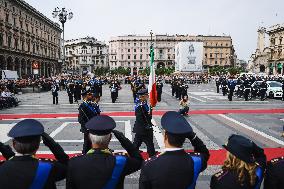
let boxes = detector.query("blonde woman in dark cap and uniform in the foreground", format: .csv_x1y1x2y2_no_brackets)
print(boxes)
210,135,266,189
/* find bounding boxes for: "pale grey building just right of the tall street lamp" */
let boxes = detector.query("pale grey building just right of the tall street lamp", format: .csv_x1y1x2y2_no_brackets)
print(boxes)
65,37,109,73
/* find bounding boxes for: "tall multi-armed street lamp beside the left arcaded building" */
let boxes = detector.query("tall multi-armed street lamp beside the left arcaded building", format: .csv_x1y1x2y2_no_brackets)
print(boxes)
52,7,73,72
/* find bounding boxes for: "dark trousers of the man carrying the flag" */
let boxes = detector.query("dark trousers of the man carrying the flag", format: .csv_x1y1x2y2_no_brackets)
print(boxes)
133,132,156,157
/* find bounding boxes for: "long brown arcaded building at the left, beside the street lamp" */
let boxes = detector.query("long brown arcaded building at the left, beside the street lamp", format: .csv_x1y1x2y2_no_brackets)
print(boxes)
0,0,62,78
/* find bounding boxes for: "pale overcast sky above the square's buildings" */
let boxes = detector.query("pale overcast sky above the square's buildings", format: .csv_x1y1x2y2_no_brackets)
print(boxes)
26,0,284,60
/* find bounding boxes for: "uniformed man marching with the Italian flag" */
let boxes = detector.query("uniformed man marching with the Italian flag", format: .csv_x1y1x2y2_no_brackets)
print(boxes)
133,89,156,156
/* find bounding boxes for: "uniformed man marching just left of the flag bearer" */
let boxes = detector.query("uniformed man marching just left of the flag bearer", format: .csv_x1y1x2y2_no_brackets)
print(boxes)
78,91,100,154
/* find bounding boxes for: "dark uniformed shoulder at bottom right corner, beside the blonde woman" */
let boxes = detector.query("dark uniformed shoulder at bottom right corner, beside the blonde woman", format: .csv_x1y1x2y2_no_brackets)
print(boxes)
264,156,284,189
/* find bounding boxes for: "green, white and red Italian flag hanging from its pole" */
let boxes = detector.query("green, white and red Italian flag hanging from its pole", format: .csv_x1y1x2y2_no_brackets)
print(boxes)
148,45,157,107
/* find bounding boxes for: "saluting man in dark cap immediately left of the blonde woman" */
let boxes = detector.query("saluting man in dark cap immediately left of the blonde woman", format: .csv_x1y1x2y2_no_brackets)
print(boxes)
139,111,209,189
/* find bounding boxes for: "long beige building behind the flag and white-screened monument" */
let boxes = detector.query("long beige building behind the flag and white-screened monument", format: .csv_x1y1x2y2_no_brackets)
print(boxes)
109,35,235,74
